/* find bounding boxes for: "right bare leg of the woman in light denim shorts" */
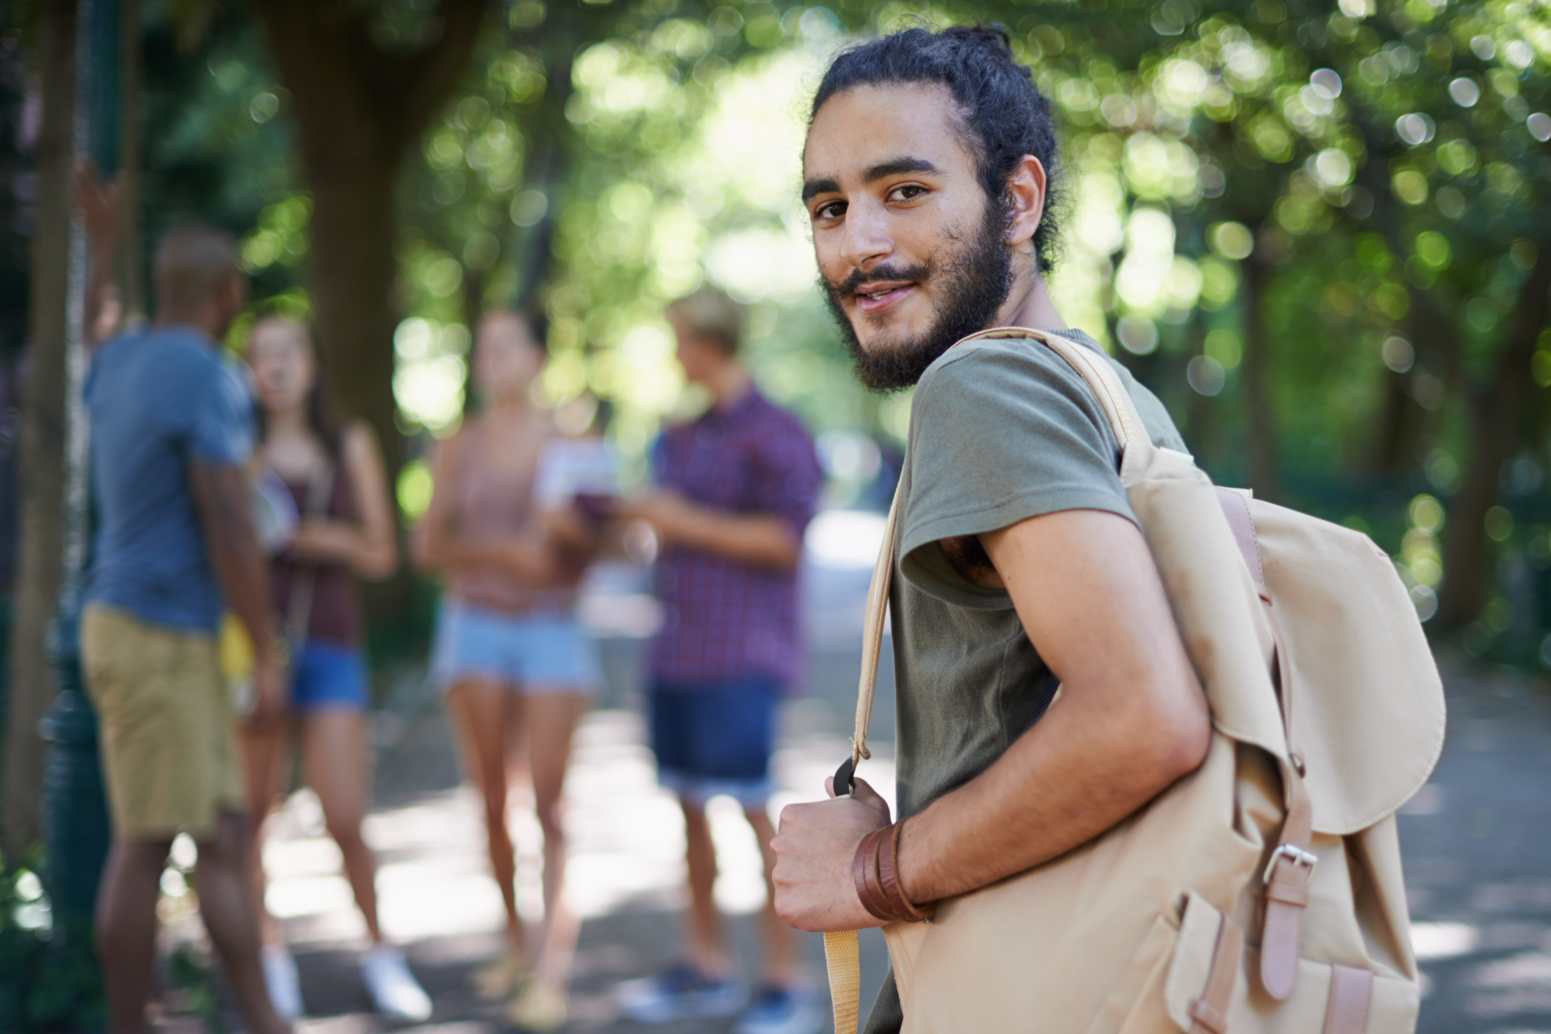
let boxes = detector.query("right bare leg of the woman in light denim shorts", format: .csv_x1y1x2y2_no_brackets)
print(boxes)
523,687,588,987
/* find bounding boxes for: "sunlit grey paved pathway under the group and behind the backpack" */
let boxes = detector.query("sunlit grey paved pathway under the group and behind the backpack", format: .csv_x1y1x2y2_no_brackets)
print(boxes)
154,598,1551,1034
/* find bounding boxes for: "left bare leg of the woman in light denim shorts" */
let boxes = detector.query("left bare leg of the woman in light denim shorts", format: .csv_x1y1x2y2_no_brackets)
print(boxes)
447,679,526,960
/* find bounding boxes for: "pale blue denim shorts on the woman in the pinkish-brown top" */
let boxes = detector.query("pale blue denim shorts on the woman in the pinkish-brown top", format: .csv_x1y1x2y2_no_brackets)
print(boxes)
431,600,600,693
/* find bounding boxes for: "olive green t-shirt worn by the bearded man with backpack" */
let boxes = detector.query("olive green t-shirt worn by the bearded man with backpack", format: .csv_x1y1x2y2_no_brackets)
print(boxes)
867,330,1187,1034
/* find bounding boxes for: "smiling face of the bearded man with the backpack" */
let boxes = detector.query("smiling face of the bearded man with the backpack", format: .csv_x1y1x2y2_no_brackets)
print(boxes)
802,84,1011,391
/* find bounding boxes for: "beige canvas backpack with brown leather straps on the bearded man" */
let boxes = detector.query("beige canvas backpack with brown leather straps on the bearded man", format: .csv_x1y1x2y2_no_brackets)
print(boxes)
825,327,1444,1034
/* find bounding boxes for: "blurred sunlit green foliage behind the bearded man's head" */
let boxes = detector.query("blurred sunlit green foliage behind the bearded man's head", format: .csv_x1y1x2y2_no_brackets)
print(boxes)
124,0,1551,653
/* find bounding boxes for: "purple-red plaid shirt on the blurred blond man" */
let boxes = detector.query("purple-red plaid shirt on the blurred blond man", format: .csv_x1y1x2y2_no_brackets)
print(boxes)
650,386,824,687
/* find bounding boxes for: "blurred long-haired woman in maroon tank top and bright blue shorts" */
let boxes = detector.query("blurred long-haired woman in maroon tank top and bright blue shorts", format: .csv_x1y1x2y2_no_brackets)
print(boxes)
239,316,431,1020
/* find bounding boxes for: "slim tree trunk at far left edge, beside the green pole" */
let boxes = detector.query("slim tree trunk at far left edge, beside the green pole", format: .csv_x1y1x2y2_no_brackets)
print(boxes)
0,0,78,856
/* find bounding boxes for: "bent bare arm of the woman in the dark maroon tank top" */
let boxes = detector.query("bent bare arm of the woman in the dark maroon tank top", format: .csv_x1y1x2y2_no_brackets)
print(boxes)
292,423,399,578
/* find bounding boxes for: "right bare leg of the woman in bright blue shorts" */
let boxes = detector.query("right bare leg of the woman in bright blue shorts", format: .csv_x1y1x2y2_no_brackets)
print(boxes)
301,707,383,944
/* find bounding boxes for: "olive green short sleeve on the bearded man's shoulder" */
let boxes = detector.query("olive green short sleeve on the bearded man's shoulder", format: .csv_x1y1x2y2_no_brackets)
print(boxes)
900,339,1135,608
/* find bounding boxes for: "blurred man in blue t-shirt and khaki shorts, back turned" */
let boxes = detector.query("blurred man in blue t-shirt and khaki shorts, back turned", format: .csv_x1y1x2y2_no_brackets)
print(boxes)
81,223,288,1034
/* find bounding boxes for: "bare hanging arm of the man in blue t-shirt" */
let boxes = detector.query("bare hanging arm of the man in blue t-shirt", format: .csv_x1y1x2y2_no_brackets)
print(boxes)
189,460,285,729
